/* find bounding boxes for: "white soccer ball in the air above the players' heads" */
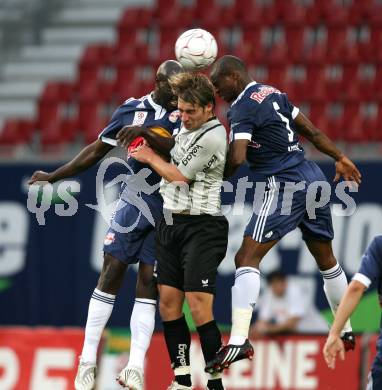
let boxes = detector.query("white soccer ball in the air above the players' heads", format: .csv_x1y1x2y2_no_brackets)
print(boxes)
175,28,218,70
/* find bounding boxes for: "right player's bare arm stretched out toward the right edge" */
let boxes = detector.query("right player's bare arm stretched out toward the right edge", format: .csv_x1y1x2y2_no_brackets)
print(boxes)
294,112,362,184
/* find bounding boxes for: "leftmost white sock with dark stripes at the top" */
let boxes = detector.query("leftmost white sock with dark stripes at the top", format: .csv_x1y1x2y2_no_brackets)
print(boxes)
81,289,115,363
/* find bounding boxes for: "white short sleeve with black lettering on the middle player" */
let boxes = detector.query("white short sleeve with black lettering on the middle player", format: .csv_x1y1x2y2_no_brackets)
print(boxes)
178,127,227,180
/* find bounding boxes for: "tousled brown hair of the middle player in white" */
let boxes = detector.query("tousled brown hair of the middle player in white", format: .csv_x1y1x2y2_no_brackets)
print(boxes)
169,72,215,107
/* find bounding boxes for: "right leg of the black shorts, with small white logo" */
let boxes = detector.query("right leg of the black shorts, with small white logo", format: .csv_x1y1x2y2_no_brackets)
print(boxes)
182,216,228,294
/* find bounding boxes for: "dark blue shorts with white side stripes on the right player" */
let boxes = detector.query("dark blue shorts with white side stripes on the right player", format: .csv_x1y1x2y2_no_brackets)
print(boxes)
244,160,333,242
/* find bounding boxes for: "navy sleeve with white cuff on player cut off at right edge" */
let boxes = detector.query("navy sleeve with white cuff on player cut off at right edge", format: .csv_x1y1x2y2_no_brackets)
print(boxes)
353,236,382,288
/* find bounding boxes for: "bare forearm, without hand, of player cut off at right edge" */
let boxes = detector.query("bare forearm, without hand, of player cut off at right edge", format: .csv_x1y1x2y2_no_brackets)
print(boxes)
329,280,365,336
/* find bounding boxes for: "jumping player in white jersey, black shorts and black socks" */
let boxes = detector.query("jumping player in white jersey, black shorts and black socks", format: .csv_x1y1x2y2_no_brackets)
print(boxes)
132,73,228,390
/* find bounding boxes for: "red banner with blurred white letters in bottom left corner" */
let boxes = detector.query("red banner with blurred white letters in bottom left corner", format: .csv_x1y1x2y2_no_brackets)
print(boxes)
0,328,83,390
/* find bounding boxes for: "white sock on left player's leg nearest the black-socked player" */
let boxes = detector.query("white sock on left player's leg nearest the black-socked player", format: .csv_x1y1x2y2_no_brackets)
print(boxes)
127,298,157,370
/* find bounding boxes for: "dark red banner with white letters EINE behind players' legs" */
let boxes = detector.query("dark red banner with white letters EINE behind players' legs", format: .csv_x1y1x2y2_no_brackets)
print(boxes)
146,334,361,390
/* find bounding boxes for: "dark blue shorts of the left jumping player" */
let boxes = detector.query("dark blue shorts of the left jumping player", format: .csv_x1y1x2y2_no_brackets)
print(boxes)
103,197,162,265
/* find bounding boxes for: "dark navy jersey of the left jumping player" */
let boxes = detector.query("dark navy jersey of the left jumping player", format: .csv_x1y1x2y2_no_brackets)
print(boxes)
98,94,180,185
